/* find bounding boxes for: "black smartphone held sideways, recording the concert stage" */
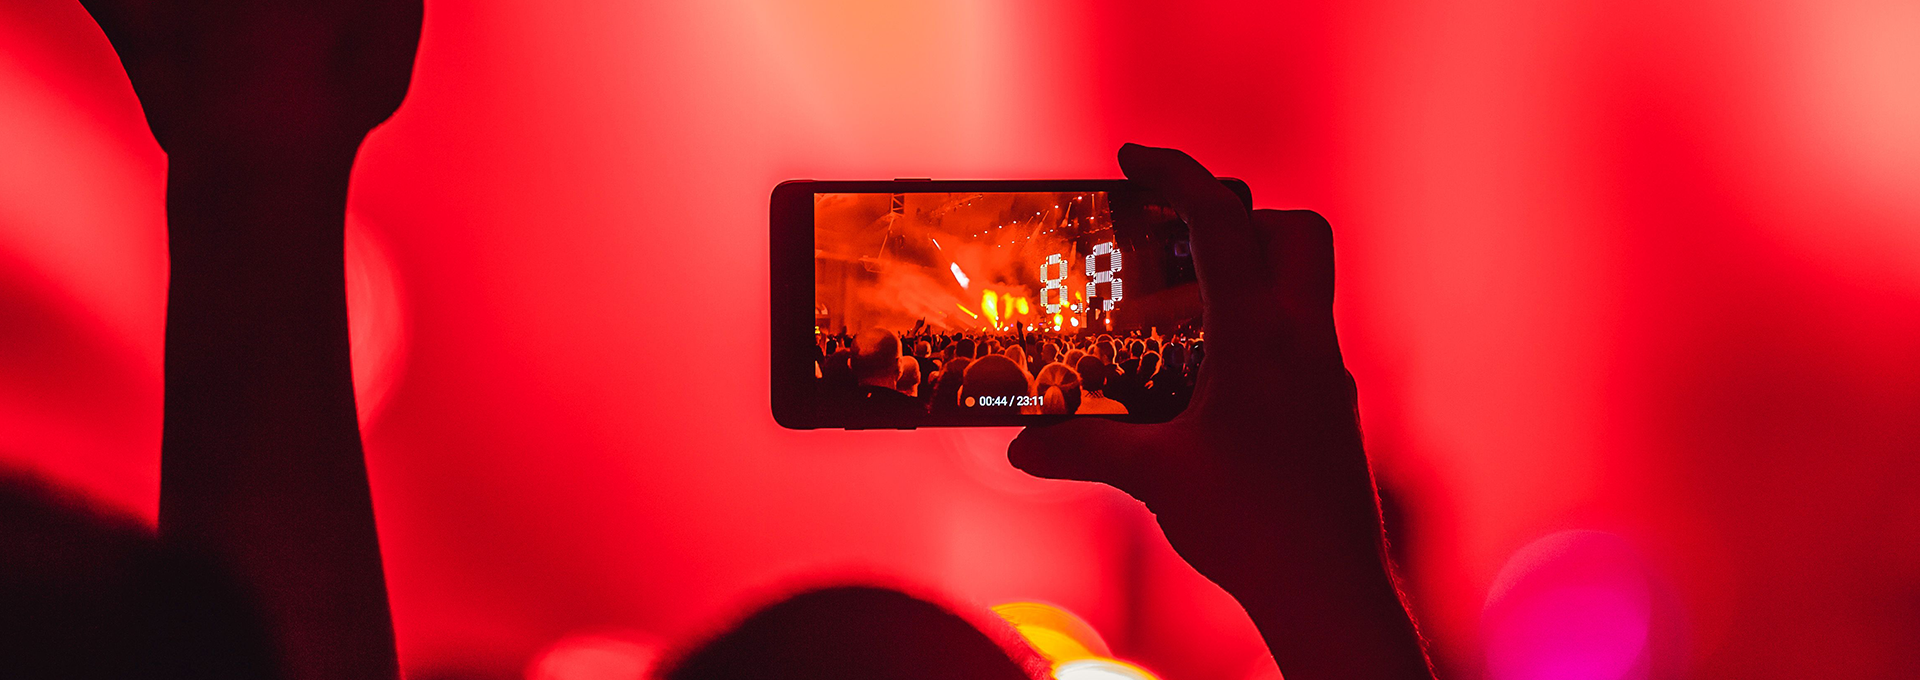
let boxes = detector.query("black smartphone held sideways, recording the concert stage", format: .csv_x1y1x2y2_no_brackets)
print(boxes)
770,179,1252,428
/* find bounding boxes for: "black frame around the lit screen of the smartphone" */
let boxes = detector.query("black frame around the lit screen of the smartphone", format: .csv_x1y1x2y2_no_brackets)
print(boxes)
768,177,1254,430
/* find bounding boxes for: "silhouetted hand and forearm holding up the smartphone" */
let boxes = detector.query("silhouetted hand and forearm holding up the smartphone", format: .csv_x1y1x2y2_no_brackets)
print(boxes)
1008,144,1432,680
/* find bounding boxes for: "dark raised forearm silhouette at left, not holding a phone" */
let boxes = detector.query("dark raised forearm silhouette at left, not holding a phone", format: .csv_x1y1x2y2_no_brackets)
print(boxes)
83,0,420,680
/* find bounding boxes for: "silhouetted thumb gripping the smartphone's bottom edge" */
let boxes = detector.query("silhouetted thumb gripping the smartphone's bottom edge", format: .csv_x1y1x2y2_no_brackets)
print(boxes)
1006,419,1162,498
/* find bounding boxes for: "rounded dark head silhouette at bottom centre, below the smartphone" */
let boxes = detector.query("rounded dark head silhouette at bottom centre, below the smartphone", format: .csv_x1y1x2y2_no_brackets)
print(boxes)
660,586,1046,680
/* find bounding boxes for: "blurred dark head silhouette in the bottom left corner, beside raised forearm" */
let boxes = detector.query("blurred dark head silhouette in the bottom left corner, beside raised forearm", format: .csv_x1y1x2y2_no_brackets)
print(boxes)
0,469,276,680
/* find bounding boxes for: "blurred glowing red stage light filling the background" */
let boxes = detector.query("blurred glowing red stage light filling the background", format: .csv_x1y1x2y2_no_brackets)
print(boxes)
0,0,1920,678
